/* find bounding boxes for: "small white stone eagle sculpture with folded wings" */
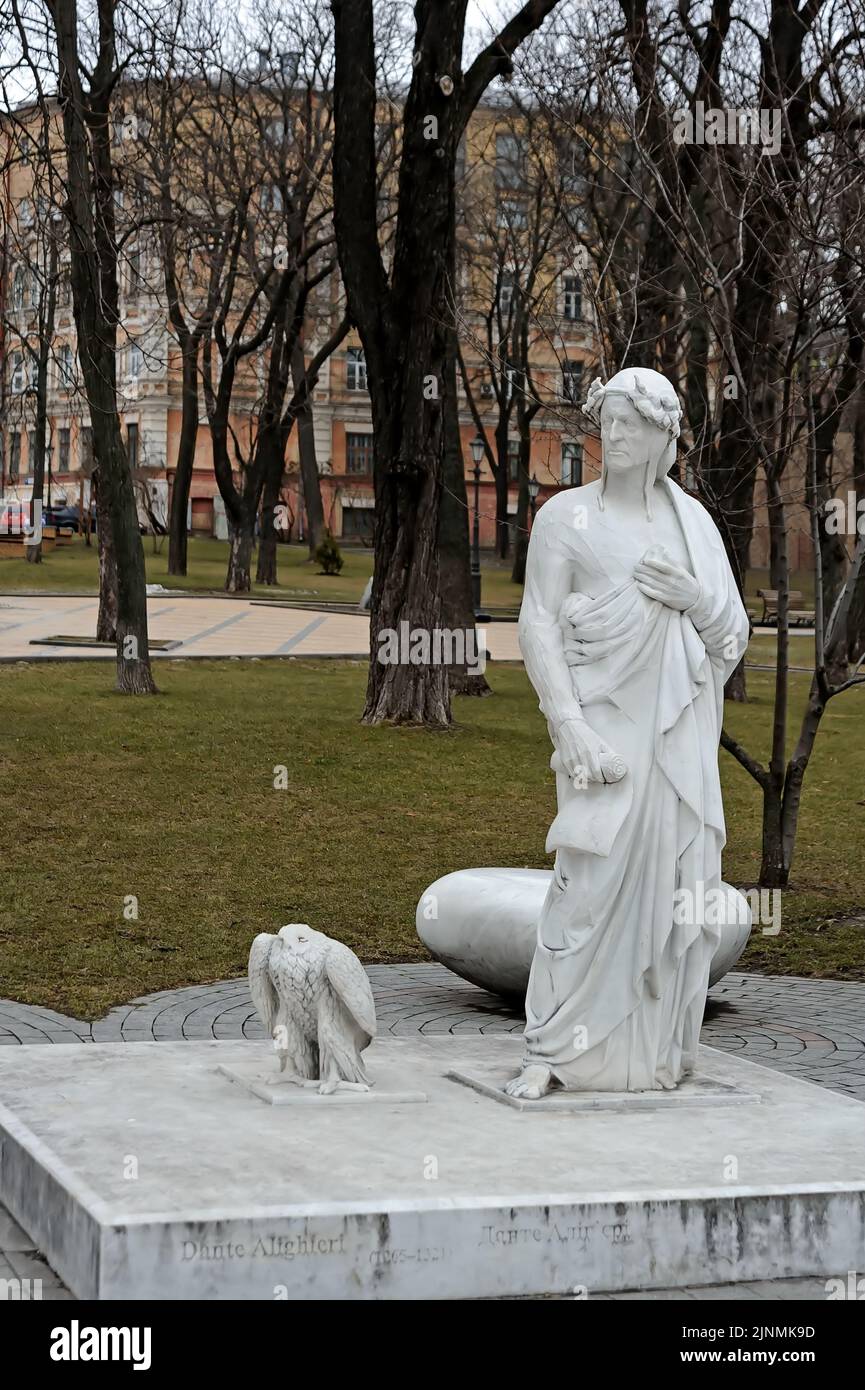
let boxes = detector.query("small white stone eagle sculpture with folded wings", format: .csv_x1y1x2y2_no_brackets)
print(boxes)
249,922,375,1095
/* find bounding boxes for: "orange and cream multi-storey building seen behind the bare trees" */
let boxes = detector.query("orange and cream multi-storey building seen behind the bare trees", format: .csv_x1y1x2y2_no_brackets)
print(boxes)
0,86,597,545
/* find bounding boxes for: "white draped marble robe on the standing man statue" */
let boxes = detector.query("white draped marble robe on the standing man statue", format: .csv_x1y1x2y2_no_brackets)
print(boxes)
520,480,748,1091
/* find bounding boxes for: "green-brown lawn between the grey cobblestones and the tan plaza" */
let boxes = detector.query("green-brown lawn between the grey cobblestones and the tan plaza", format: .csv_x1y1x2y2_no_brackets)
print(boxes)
0,660,865,1017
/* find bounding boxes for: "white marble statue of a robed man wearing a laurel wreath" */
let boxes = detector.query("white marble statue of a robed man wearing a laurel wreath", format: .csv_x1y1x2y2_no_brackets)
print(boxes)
508,368,748,1099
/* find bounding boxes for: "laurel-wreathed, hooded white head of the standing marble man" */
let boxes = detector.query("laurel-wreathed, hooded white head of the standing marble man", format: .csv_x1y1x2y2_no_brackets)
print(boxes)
583,367,681,516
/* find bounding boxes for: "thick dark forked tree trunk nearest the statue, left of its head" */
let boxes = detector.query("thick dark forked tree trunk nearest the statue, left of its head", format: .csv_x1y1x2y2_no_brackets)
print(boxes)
331,0,555,728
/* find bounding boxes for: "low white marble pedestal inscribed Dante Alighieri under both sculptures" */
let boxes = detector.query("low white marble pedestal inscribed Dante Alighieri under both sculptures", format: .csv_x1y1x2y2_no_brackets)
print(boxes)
0,1037,865,1300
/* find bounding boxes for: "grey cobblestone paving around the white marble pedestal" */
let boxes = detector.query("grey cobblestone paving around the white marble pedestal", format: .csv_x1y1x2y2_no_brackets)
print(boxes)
0,963,865,1301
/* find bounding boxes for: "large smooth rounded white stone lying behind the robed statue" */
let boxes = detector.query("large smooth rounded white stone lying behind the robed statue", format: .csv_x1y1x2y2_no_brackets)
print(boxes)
414,869,751,998
